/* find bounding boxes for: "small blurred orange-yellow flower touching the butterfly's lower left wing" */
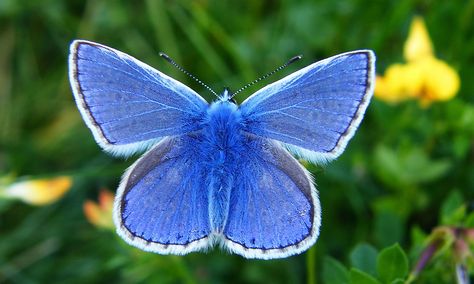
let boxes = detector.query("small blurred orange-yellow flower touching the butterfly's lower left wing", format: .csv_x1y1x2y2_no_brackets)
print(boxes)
83,190,114,229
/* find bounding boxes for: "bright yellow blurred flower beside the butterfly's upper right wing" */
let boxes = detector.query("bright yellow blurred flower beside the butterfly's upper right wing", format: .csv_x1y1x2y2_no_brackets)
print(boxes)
375,17,460,106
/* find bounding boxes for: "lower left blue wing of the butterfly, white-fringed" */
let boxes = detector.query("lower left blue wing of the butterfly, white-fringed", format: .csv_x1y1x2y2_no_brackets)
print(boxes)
114,135,210,254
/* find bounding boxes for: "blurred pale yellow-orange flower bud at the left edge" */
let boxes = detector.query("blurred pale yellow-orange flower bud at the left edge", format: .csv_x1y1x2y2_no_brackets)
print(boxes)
0,176,72,205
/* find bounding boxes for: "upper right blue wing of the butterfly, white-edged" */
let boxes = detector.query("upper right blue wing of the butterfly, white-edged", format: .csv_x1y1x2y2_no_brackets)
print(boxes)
241,50,375,162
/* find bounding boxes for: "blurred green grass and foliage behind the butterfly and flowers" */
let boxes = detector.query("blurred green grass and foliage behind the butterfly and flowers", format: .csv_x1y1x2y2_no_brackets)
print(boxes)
0,0,474,283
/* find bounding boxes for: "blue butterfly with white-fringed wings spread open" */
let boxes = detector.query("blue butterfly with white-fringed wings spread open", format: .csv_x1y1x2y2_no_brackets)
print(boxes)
69,40,375,259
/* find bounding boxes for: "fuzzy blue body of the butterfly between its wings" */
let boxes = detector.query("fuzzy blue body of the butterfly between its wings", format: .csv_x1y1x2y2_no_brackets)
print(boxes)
202,101,243,233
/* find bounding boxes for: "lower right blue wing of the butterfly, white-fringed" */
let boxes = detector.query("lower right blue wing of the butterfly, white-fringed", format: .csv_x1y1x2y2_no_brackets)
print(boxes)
223,136,321,259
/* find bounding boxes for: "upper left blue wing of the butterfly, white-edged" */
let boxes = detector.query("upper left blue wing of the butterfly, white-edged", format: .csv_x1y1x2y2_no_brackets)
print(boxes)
69,40,207,155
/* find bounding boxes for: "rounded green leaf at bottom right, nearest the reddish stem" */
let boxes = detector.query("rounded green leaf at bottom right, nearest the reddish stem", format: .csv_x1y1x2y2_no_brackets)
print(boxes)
377,243,408,283
